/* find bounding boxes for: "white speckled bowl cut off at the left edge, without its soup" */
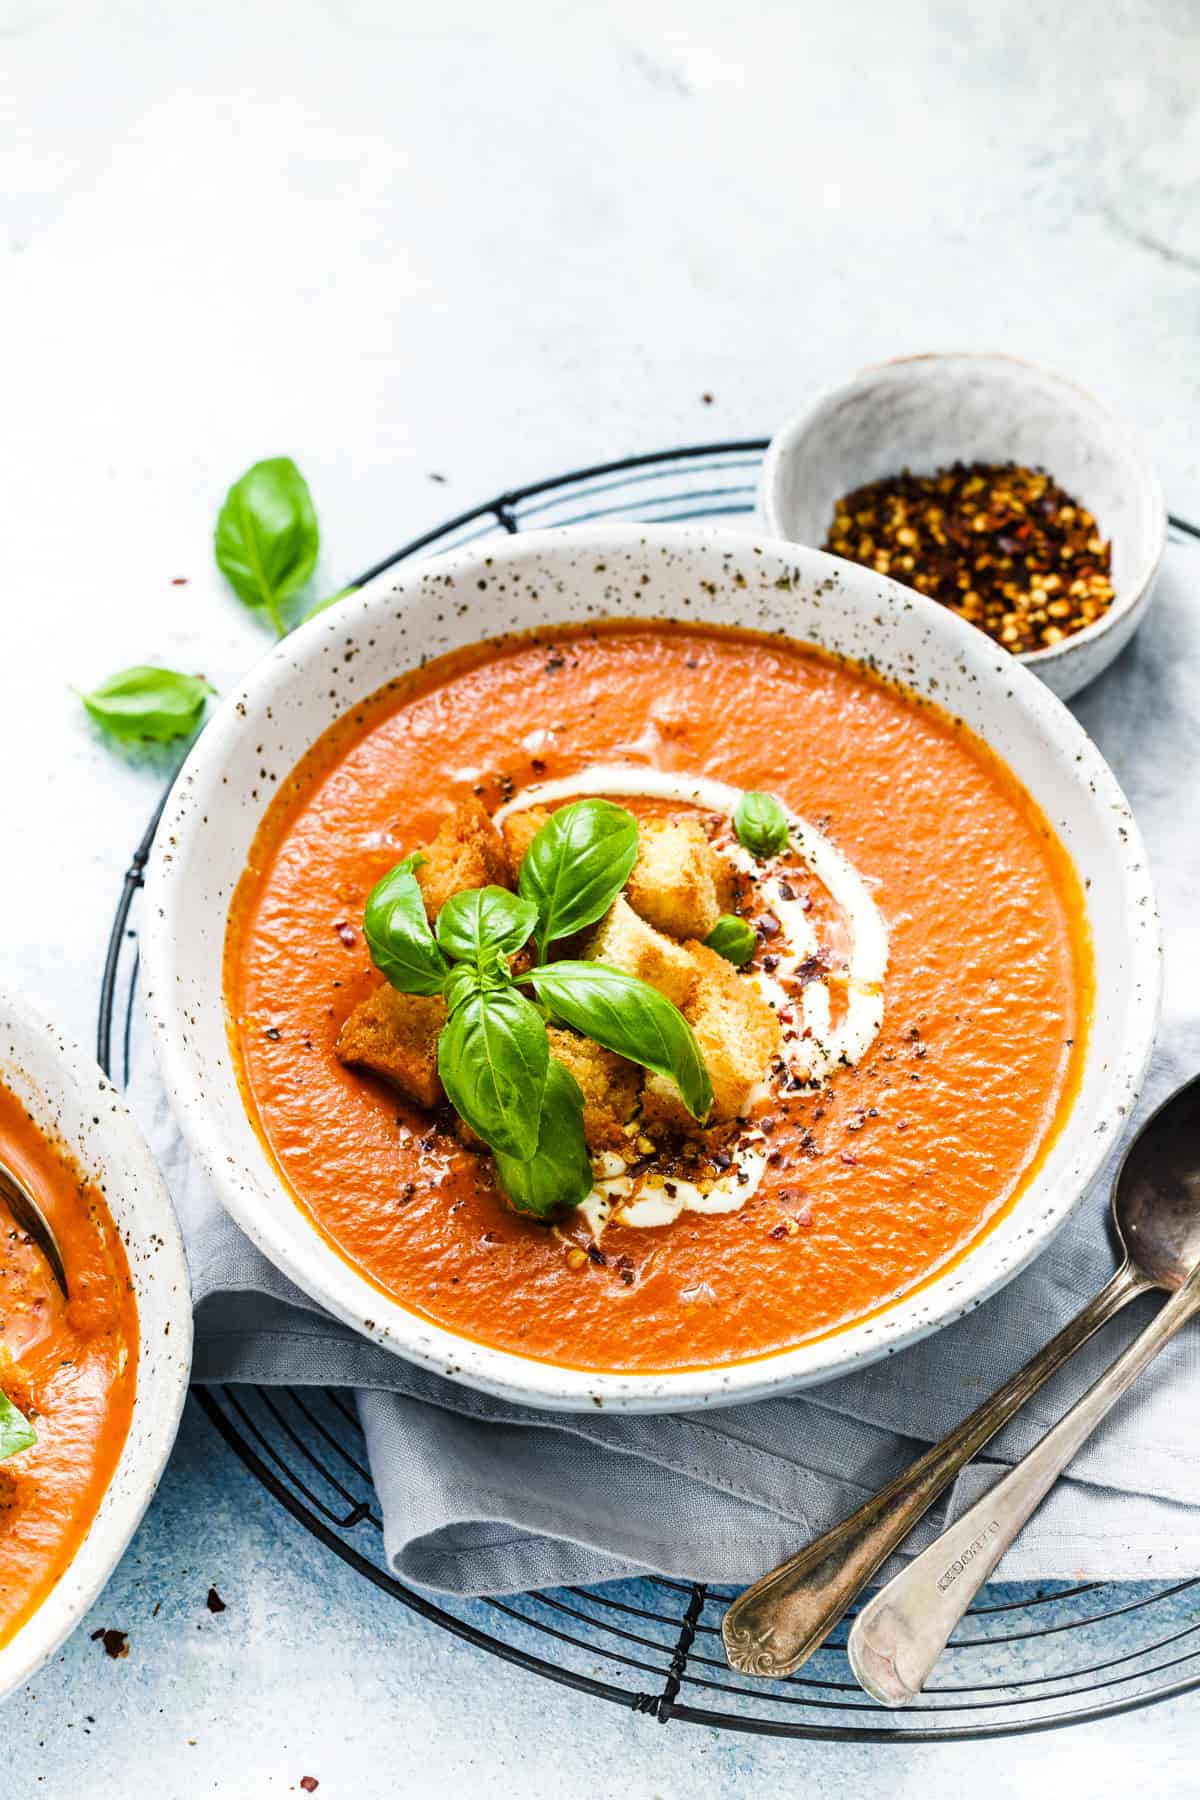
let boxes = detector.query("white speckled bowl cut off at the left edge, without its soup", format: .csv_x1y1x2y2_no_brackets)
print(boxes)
0,994,193,1699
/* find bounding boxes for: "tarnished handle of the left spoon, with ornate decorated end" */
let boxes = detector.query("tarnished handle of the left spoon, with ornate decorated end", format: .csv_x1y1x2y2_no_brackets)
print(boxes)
721,1264,1148,1679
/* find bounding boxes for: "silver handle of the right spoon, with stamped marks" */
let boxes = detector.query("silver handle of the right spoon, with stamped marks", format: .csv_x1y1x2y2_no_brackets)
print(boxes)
847,1267,1200,1706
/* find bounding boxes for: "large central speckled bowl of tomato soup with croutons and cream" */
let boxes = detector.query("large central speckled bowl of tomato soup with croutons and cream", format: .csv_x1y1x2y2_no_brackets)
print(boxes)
144,526,1159,1411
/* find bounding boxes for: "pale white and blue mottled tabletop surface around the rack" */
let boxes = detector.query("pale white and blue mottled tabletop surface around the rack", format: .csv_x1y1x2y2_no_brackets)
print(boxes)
0,0,1200,1800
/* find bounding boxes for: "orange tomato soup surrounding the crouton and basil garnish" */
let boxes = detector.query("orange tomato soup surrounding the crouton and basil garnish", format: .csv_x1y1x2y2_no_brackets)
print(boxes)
225,623,1092,1372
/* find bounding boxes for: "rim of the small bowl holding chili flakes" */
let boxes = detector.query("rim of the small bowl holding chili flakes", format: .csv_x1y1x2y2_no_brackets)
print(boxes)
757,349,1168,671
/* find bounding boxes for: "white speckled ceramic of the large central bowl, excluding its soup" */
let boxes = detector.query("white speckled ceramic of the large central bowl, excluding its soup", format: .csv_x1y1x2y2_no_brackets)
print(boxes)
142,524,1159,1411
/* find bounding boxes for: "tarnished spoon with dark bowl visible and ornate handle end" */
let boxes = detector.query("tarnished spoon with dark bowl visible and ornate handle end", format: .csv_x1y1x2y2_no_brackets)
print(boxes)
721,1076,1200,1677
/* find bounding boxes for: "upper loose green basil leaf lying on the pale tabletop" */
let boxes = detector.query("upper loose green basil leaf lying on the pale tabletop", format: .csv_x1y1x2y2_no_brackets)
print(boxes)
212,455,320,637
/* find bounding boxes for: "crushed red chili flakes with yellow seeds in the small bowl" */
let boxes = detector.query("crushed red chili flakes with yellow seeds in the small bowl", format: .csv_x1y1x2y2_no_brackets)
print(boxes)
824,463,1114,653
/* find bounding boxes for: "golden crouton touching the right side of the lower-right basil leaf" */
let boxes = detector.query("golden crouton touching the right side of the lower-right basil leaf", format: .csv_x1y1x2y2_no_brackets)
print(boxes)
642,943,783,1129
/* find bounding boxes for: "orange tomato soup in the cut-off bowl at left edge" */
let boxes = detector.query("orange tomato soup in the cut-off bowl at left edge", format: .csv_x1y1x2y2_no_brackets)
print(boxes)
0,1087,137,1643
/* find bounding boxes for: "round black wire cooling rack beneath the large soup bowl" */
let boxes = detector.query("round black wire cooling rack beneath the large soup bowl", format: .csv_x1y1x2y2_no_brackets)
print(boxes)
97,439,1200,1742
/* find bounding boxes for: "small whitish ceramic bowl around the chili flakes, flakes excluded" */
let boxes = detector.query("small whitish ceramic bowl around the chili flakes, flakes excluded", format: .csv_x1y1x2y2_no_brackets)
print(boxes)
759,353,1166,700
